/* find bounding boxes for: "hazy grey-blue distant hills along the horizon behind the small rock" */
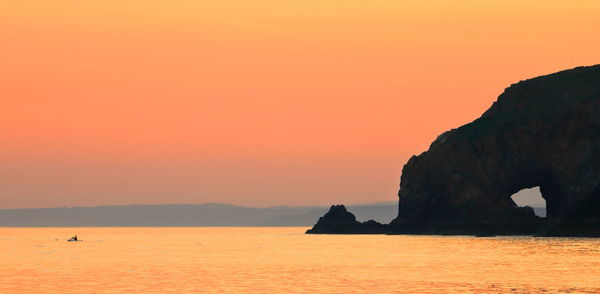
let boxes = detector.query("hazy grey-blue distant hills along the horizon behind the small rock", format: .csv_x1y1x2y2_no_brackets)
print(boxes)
0,202,398,227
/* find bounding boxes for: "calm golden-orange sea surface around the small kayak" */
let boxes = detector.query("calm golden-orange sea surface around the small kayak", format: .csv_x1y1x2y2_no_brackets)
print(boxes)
0,228,600,294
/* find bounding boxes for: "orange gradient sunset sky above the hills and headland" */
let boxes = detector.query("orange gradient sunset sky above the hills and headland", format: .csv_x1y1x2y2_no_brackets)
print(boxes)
0,0,600,208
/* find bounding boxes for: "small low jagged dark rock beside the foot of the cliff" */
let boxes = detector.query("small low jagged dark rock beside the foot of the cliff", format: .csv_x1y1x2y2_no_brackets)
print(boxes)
306,205,387,234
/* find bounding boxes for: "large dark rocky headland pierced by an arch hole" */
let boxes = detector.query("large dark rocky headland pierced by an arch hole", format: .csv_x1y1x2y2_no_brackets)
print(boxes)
390,66,600,236
